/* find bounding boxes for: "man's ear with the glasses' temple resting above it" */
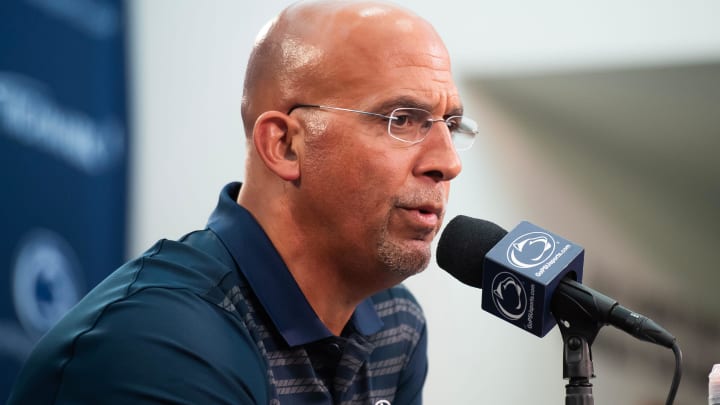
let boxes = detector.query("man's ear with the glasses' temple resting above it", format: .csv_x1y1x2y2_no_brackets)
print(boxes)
253,111,301,181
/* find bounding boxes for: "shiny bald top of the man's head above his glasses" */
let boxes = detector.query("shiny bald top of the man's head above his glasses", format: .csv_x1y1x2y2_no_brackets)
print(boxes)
242,0,449,136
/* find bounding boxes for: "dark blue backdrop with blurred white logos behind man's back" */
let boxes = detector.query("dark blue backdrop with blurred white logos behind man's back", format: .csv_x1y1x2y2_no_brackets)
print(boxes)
0,0,128,403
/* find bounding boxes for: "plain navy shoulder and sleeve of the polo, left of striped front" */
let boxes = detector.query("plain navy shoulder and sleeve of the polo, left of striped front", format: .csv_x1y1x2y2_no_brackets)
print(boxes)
8,231,267,404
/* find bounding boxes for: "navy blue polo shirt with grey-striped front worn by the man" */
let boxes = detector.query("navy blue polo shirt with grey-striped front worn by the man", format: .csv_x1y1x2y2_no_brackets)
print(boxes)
9,183,427,405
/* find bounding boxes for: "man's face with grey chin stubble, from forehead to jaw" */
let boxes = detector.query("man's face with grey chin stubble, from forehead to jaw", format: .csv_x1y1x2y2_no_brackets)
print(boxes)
293,15,462,282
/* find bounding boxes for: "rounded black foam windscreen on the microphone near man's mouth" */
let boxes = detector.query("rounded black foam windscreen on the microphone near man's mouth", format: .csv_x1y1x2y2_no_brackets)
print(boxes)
437,215,507,288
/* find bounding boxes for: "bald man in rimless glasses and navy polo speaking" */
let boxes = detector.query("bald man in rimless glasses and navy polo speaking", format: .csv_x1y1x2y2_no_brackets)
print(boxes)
10,0,476,404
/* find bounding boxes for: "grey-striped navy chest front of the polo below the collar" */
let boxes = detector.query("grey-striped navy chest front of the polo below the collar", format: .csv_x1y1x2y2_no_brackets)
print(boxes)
218,281,425,405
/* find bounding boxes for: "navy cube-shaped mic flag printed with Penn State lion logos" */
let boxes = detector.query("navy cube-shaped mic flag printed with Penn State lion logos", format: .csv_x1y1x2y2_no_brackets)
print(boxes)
482,221,584,337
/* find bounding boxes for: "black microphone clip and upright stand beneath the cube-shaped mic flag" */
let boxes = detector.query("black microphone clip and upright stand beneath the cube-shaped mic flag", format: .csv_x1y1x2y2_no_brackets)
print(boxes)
551,280,604,405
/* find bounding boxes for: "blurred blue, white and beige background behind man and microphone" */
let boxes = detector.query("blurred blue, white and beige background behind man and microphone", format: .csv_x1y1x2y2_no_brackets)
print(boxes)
0,0,720,405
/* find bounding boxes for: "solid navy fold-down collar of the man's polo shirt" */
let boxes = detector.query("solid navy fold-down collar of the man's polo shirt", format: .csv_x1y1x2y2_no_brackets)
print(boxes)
208,182,383,346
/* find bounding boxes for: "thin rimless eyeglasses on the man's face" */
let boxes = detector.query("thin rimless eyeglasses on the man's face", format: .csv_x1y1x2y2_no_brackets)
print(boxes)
288,104,479,151
